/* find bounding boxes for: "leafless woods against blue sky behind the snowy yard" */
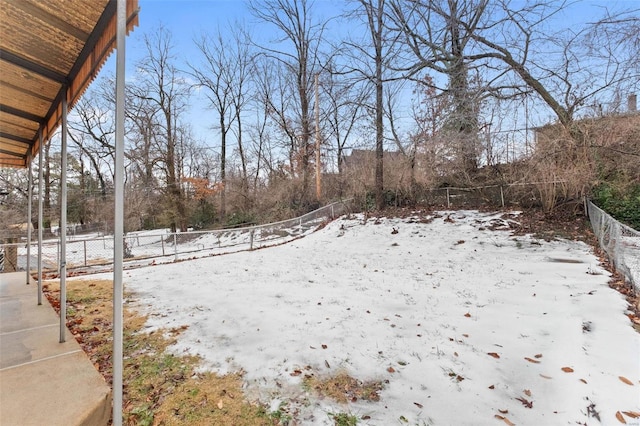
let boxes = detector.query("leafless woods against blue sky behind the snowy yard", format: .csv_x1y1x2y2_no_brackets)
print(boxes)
0,0,640,231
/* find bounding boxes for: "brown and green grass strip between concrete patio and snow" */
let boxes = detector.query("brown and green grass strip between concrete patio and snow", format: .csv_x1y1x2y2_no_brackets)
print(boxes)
45,280,280,426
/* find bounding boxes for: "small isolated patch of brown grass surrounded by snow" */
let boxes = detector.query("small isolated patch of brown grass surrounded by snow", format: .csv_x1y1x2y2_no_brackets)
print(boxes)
303,372,383,403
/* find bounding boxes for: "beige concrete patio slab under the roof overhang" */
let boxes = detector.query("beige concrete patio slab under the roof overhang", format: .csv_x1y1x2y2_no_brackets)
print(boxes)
0,272,112,426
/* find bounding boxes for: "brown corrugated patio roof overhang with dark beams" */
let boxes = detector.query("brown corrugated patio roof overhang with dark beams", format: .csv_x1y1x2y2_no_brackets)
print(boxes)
0,0,138,167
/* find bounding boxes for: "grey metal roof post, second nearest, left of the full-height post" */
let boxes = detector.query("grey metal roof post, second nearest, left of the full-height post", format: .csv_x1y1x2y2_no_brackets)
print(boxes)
60,88,69,343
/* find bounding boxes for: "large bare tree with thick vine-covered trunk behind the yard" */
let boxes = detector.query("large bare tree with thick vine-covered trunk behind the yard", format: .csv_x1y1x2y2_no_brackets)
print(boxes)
390,0,489,173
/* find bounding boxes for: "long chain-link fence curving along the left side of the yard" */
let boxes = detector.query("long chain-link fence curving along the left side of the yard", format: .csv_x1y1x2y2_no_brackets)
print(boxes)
0,201,351,273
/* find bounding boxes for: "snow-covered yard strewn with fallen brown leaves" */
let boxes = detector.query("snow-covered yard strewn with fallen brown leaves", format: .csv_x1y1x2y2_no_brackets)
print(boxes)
112,211,640,425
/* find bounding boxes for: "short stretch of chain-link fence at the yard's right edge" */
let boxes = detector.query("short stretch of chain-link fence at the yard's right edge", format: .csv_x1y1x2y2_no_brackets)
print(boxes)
587,200,640,291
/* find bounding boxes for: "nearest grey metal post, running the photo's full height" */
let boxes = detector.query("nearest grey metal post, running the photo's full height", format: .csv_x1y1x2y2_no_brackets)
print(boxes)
112,0,127,426
